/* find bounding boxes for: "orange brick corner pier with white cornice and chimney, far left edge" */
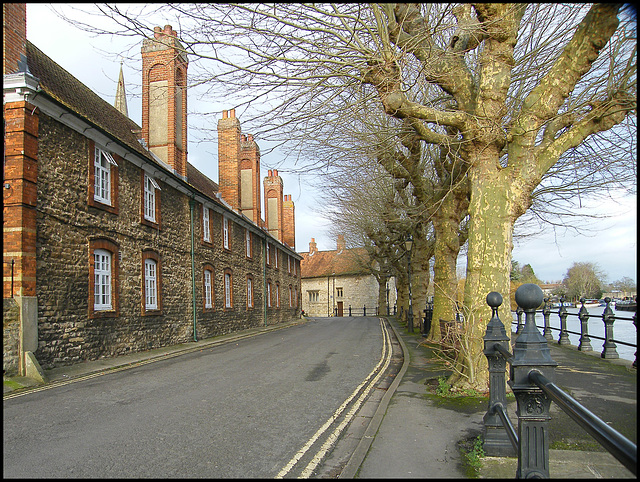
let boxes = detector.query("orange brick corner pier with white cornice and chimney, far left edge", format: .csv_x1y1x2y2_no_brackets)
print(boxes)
2,3,40,306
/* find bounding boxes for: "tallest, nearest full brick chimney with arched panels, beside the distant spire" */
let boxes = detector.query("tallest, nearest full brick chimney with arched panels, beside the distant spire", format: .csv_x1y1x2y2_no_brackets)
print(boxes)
142,25,189,179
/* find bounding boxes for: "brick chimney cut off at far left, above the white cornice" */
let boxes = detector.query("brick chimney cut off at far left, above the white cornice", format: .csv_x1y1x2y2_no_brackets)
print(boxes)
2,3,27,75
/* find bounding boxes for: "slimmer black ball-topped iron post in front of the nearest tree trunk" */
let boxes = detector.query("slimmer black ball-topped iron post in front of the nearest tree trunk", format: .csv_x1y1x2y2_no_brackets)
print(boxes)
482,291,515,457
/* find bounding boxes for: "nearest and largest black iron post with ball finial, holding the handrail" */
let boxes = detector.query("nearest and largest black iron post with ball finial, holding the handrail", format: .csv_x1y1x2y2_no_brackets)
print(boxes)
509,283,558,479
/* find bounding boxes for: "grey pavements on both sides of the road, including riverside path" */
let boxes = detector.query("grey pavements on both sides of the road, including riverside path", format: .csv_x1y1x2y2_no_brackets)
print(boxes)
3,317,637,479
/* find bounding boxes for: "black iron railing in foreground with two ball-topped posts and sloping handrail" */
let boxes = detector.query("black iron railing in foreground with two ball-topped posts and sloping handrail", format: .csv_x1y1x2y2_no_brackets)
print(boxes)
483,283,637,478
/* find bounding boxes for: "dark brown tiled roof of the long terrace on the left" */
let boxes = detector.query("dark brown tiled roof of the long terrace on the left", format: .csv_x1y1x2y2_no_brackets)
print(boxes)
27,41,218,201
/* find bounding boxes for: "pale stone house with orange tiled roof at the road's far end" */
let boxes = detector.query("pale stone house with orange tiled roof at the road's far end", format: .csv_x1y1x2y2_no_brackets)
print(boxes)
300,235,397,316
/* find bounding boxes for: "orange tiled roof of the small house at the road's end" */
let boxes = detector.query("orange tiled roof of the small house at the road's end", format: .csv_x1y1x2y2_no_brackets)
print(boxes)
299,248,371,278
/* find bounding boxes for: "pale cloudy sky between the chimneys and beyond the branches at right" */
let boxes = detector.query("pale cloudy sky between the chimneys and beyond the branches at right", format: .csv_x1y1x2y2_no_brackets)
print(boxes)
27,3,637,282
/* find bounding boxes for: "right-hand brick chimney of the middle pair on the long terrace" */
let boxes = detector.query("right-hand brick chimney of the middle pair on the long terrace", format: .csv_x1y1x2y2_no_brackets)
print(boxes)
240,134,262,226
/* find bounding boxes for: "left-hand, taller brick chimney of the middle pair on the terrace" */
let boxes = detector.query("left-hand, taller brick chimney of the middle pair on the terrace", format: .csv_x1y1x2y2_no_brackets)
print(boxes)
218,109,241,210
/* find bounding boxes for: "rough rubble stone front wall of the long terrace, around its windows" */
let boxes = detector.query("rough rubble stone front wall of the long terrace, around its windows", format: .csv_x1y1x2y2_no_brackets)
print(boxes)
35,115,299,369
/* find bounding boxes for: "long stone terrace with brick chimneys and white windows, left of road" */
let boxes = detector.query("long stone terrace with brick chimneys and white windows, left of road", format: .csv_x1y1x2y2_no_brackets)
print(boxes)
3,4,302,374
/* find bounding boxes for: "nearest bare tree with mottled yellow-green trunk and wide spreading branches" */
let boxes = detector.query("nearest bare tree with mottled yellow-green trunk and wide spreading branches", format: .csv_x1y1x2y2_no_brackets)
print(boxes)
57,4,637,388
